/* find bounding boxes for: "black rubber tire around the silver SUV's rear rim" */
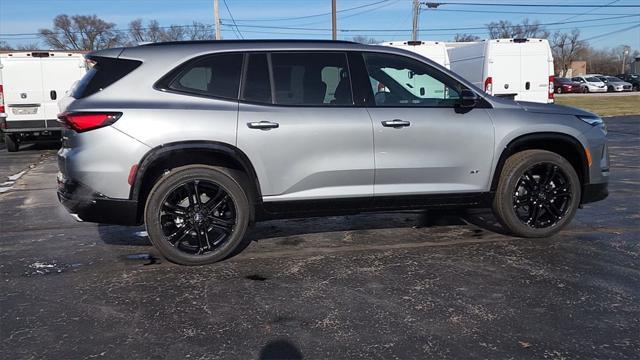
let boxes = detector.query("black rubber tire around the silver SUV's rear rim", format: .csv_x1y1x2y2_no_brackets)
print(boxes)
144,165,250,265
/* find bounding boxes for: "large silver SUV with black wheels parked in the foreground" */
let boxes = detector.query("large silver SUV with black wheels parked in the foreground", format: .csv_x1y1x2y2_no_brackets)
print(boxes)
58,41,609,265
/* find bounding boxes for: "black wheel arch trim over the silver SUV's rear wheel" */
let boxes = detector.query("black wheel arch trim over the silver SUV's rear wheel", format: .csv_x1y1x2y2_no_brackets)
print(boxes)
129,140,262,202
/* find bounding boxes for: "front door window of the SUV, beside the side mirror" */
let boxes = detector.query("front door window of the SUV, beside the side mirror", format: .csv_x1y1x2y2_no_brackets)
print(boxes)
364,53,462,107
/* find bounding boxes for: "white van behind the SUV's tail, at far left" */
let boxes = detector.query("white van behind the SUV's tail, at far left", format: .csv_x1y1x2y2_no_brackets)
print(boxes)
0,51,86,152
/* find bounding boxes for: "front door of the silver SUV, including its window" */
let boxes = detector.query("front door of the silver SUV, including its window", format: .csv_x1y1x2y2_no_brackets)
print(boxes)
353,53,494,204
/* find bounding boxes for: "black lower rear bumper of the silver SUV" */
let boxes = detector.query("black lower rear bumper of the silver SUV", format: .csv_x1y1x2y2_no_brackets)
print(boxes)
58,173,140,225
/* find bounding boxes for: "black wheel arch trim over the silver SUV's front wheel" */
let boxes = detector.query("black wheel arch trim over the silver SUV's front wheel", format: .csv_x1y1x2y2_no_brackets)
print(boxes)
490,132,589,191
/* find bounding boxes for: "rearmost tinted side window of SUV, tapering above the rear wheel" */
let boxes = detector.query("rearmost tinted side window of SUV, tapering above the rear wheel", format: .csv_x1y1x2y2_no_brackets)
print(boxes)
169,54,242,99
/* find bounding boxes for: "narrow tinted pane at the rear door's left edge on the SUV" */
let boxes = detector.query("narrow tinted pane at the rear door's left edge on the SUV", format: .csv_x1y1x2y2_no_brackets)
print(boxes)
241,54,272,104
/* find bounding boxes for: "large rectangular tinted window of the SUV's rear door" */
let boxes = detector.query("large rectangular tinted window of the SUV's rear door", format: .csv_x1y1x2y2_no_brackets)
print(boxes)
271,53,353,106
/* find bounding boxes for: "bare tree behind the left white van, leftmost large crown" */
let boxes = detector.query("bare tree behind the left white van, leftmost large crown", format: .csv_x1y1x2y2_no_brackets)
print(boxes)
38,14,122,50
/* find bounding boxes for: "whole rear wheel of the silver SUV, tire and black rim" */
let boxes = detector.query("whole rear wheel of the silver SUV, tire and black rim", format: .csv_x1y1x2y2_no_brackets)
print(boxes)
144,165,250,265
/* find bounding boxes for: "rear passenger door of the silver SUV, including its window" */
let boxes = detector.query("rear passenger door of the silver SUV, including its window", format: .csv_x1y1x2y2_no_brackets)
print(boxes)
237,51,374,210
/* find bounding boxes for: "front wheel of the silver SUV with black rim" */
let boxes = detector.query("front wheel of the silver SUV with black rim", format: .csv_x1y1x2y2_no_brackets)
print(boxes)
493,150,582,238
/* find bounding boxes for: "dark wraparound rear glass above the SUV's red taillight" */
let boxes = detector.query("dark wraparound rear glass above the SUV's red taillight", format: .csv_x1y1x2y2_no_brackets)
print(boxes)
71,57,142,99
